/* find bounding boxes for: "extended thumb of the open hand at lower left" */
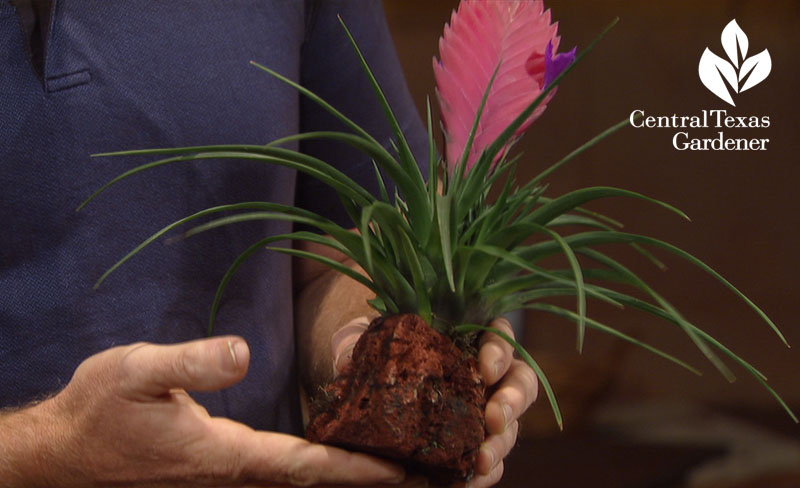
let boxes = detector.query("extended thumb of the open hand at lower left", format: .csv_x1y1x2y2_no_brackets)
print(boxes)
120,336,250,397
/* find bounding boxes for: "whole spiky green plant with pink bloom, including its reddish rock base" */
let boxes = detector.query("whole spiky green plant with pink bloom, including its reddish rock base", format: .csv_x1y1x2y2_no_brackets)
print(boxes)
79,0,797,481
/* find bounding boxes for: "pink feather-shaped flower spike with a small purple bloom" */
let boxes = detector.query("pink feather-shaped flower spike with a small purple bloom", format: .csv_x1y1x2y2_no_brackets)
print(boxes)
433,0,575,174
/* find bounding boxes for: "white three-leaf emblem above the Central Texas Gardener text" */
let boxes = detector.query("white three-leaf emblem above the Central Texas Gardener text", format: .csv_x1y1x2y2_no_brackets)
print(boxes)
698,19,772,107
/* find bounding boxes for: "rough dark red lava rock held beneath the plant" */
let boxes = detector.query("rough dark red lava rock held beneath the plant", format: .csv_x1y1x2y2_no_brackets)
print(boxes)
306,315,486,484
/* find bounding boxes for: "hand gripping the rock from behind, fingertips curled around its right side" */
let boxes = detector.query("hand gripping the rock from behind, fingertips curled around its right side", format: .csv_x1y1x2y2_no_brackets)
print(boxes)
331,317,539,488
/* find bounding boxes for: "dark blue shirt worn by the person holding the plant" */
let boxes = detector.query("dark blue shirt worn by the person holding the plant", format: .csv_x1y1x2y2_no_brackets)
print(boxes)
0,0,426,433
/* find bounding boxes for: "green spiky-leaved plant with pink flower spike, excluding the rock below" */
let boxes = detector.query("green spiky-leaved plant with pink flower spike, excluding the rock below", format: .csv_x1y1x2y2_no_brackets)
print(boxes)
82,0,797,482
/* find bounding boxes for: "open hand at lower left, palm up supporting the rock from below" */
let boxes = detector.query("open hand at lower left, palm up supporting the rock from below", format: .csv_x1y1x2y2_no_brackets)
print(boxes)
0,337,404,487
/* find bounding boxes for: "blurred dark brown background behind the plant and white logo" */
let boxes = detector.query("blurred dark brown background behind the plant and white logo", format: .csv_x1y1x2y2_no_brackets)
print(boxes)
384,0,800,488
